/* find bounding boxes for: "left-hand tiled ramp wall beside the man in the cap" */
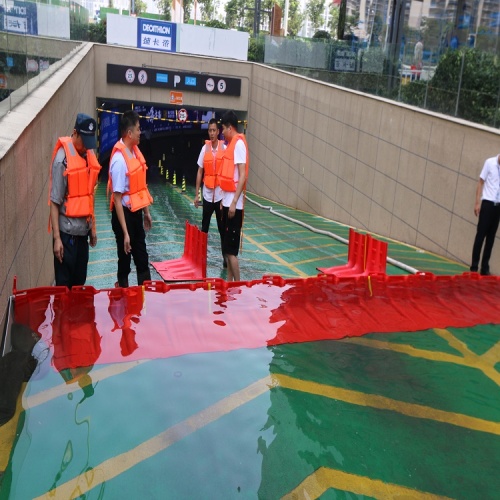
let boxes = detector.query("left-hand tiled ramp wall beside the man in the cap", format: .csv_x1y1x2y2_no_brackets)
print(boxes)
0,44,95,317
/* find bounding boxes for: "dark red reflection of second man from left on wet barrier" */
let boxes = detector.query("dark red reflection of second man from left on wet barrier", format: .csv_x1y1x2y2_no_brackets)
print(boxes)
108,287,143,356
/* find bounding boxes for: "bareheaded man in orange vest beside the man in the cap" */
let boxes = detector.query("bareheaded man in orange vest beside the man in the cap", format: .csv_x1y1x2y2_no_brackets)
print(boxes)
108,111,153,287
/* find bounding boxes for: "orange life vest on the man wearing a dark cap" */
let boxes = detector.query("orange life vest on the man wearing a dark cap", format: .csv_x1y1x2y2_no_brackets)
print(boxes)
49,137,101,219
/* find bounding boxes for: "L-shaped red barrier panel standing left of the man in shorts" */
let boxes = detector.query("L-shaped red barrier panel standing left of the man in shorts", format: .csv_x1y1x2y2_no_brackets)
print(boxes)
151,221,207,281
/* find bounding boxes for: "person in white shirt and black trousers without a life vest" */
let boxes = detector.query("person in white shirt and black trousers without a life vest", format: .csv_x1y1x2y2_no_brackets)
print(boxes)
470,155,500,276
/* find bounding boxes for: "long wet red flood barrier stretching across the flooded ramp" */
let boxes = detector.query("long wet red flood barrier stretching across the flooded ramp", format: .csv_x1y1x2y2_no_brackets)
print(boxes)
9,273,500,371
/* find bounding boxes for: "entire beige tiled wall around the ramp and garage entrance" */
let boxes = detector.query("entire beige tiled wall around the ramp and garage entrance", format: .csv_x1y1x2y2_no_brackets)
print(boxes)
0,44,500,317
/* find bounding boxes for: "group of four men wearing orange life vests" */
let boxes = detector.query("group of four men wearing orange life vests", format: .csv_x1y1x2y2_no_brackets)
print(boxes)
49,110,248,288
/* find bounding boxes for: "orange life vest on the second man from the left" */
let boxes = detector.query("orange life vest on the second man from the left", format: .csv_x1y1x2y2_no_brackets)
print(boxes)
108,141,153,212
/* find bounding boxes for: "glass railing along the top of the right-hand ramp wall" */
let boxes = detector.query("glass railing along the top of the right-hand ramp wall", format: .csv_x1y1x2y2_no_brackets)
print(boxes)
258,36,500,128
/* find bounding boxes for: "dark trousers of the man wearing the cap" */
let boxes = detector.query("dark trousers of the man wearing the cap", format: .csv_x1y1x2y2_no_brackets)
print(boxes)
54,231,89,288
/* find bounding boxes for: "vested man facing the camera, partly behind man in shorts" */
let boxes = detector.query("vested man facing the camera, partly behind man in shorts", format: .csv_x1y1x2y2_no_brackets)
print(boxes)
194,118,227,267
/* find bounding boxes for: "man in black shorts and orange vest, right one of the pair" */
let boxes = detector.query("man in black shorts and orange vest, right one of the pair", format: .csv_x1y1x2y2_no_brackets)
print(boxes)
217,111,249,281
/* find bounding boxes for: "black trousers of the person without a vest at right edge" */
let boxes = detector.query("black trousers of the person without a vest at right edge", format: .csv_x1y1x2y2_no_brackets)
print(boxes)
470,200,500,274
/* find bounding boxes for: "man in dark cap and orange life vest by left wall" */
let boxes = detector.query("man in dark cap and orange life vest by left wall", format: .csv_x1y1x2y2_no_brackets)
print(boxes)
49,113,101,288
